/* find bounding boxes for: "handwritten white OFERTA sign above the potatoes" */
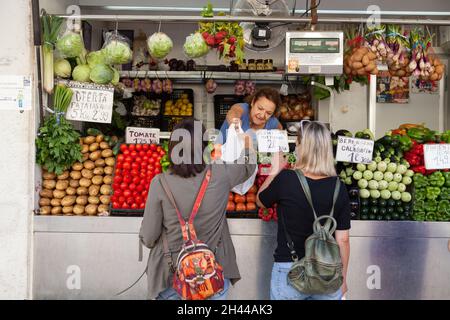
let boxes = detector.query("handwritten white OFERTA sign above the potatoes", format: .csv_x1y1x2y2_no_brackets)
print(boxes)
61,81,114,123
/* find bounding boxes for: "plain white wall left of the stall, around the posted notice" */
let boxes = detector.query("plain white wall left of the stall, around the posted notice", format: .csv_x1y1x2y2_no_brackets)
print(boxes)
0,0,34,299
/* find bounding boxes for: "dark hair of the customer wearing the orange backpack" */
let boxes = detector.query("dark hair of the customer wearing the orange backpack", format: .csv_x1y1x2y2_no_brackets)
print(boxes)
169,118,208,178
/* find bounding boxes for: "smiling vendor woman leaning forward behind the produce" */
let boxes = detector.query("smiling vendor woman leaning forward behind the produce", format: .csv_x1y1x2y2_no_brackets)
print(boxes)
218,88,283,144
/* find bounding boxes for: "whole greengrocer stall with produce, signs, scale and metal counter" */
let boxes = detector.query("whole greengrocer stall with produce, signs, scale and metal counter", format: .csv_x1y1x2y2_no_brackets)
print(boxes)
33,1,450,299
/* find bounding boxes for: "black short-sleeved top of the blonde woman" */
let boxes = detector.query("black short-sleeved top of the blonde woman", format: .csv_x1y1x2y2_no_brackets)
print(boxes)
259,170,350,262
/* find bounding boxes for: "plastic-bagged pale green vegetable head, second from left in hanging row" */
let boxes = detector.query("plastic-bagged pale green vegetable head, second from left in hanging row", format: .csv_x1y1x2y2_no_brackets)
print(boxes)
102,31,133,64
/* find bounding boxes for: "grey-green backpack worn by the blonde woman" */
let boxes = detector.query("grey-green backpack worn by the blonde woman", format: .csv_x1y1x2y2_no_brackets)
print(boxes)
280,170,343,294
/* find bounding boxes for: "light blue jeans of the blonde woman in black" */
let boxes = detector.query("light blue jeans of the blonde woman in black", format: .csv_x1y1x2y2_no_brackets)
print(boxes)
270,262,342,300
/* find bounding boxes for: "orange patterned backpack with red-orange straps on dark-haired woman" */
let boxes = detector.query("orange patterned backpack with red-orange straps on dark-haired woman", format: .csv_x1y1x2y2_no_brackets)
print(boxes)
161,170,224,300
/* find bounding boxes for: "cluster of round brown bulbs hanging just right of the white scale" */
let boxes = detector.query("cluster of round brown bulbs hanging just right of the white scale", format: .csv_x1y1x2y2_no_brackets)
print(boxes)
344,47,378,76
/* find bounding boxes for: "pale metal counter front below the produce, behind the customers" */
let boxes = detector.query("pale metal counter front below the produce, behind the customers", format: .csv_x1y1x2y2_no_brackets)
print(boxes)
33,216,450,300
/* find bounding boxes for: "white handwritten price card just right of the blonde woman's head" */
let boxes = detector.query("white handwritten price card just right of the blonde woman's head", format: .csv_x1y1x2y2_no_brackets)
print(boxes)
336,136,374,164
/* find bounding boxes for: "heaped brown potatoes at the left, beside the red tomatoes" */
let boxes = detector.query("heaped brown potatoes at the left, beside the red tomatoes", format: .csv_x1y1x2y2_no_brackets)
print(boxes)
39,135,115,216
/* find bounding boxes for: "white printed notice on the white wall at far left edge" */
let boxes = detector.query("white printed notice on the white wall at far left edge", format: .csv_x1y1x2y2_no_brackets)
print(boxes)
0,75,32,110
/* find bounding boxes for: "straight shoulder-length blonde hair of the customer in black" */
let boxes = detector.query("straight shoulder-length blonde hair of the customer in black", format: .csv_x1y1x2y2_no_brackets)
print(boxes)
297,122,336,176
